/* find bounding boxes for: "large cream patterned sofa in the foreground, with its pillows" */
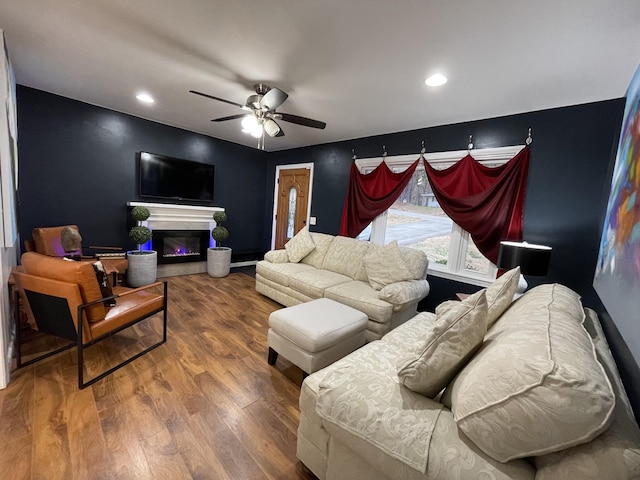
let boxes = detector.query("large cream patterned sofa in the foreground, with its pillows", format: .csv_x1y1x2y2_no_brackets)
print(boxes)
297,270,640,480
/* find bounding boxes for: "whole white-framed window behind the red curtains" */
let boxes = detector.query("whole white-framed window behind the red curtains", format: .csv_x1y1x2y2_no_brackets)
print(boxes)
356,145,523,286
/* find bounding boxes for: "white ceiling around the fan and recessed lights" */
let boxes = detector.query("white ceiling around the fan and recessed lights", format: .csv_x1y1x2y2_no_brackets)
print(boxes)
0,0,640,151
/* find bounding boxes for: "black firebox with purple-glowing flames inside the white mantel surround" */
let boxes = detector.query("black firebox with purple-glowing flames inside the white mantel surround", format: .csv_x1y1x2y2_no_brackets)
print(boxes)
152,230,209,265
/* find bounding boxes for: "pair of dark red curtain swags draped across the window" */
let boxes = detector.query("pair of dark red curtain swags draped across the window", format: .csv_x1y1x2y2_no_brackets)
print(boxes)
340,148,530,263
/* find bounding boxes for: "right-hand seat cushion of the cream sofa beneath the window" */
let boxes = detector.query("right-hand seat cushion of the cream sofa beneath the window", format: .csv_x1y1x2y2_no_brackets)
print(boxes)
324,280,393,324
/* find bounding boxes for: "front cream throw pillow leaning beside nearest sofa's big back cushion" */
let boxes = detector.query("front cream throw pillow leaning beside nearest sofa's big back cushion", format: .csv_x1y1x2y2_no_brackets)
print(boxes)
397,290,487,398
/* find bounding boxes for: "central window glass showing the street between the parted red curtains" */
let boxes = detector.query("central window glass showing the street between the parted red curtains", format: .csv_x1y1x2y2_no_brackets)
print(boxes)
384,168,453,265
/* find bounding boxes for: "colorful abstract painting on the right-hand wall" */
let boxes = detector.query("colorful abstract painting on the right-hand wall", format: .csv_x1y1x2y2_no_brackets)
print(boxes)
593,61,640,364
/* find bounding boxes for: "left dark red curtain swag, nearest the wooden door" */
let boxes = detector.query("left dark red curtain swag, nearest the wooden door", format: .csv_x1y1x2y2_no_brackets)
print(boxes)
340,159,420,238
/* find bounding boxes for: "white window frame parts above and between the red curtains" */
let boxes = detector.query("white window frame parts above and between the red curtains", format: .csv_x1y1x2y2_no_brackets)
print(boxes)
355,145,525,287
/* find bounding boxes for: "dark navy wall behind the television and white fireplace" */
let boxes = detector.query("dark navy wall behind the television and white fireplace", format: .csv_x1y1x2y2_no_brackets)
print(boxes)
17,86,267,253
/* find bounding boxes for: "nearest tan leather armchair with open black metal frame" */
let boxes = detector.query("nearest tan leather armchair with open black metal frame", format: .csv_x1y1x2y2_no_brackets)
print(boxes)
12,252,167,389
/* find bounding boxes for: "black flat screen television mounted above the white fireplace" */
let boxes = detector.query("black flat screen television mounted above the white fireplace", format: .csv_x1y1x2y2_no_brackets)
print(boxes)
139,152,215,202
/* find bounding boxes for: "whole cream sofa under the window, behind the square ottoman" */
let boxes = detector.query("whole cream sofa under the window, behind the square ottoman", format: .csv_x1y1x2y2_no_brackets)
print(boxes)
256,227,429,341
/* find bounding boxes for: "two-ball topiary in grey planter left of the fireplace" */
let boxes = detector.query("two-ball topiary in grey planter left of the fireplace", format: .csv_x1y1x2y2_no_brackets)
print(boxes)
127,206,158,287
